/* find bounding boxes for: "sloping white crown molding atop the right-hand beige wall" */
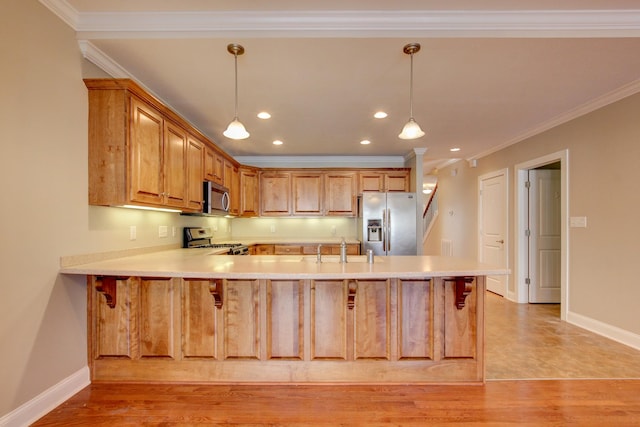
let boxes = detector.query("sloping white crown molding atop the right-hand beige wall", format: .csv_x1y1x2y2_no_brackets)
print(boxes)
467,79,640,160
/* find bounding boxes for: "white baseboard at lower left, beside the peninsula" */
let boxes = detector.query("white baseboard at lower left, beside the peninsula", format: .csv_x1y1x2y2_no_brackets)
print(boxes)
0,366,91,427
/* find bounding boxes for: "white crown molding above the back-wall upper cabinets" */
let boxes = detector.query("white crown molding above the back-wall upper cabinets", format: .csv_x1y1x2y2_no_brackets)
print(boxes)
234,156,405,168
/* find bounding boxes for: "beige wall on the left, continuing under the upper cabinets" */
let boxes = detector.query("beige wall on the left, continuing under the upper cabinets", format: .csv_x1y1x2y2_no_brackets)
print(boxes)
0,0,229,417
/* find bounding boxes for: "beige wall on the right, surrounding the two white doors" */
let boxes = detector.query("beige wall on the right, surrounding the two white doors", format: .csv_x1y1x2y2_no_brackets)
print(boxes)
425,94,640,340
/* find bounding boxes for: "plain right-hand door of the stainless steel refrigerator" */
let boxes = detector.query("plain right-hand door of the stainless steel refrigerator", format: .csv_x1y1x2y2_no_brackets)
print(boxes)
385,193,418,255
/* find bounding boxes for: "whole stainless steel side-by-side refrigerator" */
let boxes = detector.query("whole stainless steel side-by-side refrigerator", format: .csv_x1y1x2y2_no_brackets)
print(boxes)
358,192,417,255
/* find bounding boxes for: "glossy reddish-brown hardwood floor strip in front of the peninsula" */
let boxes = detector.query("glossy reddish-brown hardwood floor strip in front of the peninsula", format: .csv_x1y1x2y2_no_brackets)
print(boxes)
35,380,640,427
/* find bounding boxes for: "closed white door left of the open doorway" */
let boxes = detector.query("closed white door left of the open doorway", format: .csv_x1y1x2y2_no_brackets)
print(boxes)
478,170,508,296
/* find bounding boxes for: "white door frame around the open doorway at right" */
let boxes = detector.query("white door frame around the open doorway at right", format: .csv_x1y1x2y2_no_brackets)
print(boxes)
508,150,569,320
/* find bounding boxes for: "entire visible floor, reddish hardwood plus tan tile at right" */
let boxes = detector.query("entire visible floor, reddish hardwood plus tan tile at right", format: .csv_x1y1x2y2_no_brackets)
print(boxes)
34,294,640,426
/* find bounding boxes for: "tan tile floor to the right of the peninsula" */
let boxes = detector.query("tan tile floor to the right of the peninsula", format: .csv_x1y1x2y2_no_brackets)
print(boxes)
485,292,640,380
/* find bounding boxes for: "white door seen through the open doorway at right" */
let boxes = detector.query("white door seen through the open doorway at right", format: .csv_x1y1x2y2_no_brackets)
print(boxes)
529,169,561,303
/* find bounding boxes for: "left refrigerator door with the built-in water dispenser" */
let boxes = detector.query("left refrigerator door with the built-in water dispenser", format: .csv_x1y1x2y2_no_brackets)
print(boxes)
359,192,387,255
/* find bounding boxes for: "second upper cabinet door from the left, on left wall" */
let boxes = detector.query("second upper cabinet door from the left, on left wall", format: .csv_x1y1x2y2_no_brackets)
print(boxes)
164,122,187,208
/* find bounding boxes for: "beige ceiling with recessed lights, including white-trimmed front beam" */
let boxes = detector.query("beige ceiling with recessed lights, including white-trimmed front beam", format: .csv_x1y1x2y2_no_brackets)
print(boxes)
41,0,640,169
